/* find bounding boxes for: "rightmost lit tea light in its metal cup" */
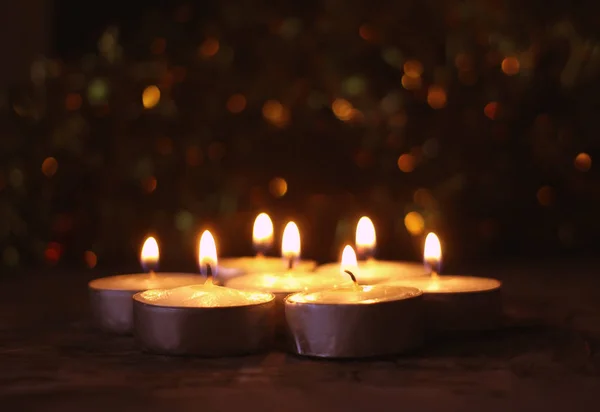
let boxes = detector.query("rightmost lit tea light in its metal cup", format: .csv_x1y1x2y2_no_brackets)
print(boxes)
390,233,502,332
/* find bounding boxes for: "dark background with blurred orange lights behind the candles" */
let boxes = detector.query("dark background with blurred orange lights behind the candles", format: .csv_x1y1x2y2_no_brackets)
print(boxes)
0,0,600,273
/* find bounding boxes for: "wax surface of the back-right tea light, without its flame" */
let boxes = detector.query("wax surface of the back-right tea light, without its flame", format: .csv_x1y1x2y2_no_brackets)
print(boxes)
316,259,429,284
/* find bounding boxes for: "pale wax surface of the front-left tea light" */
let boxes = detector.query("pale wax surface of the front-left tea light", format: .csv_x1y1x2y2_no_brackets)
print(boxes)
138,283,273,308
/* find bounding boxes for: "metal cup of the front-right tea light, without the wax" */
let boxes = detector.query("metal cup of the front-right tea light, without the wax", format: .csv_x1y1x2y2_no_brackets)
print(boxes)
285,286,424,358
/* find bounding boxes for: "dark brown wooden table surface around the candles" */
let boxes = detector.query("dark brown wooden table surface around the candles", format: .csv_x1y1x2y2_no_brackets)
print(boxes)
0,261,600,412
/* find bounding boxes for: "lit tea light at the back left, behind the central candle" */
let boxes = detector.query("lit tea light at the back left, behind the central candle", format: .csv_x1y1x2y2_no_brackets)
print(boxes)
219,213,317,282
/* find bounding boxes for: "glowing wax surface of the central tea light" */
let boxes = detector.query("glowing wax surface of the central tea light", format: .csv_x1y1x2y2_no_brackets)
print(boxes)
226,270,352,293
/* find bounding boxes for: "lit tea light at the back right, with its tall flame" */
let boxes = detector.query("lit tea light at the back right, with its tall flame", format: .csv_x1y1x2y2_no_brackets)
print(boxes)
316,216,429,285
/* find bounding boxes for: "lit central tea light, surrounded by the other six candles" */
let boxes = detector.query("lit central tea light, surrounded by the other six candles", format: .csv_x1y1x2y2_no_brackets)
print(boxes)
225,222,350,325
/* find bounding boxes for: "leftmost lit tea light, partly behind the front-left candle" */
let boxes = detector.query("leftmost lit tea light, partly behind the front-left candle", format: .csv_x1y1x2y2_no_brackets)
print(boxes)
88,237,202,334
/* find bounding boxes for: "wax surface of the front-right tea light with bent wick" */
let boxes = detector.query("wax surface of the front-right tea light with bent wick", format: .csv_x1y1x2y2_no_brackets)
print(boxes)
288,285,421,304
